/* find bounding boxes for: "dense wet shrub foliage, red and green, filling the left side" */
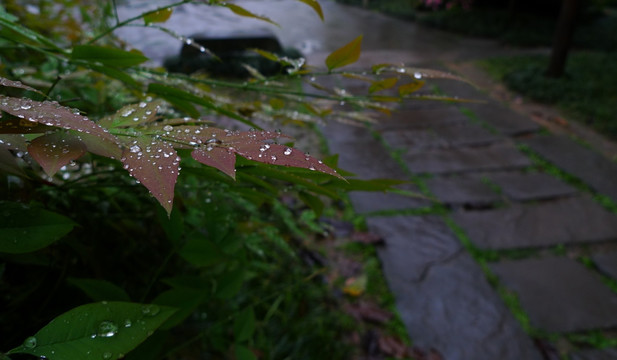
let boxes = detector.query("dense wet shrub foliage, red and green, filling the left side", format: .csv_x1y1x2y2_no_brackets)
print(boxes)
0,0,466,360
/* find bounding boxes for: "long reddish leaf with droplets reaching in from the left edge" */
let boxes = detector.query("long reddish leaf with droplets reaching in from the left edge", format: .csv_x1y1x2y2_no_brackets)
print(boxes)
0,95,118,143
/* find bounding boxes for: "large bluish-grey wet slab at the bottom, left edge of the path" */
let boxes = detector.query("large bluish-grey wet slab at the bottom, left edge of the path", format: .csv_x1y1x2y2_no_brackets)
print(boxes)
368,216,542,360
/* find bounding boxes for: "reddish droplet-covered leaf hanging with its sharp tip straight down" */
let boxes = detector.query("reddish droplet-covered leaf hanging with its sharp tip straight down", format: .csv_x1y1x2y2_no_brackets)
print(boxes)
120,136,180,214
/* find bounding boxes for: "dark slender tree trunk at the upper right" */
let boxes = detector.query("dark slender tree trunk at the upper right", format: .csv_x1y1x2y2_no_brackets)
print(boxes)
546,0,581,78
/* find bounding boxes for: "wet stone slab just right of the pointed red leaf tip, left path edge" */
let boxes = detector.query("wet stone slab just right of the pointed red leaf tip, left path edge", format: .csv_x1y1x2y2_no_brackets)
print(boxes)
322,122,408,180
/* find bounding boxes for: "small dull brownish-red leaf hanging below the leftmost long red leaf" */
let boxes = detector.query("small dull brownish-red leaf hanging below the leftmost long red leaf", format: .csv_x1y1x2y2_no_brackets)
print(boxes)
28,131,86,176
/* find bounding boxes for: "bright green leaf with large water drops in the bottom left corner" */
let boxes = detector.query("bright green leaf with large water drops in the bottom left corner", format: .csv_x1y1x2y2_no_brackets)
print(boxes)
9,301,176,360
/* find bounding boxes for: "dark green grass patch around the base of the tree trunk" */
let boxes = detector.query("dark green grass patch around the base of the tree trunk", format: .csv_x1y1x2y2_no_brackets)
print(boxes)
480,52,617,139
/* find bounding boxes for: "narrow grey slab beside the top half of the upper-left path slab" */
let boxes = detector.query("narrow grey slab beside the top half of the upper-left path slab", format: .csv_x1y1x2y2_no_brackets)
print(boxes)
382,121,502,150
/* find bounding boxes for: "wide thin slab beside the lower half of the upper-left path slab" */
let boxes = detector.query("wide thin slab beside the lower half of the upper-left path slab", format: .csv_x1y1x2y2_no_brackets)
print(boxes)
403,143,531,174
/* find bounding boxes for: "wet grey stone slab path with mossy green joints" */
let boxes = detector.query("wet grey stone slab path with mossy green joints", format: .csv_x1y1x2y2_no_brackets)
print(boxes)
323,57,617,360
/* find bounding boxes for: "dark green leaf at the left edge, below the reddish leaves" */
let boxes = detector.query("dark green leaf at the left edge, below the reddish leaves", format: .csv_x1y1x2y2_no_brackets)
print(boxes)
0,202,77,254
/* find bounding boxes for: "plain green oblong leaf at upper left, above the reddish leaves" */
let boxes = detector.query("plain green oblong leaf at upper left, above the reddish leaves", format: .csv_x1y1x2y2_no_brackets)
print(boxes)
71,45,148,67
